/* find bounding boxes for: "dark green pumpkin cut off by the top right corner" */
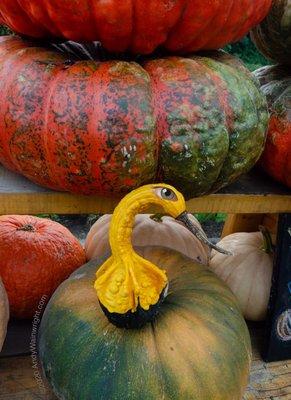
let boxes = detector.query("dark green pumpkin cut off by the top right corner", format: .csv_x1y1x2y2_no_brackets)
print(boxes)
252,0,291,65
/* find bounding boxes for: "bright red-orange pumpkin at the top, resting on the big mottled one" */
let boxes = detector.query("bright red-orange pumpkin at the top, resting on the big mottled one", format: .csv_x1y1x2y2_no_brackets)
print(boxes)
0,0,271,54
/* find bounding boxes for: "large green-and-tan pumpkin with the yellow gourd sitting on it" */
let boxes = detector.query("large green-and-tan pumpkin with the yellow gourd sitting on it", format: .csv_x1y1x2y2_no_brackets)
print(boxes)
39,248,251,400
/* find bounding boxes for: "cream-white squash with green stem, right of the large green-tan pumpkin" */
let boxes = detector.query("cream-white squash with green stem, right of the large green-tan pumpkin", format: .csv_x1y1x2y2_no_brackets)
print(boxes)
210,232,273,321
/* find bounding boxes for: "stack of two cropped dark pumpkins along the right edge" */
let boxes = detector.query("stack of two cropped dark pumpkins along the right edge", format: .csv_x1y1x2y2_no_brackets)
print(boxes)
252,0,291,188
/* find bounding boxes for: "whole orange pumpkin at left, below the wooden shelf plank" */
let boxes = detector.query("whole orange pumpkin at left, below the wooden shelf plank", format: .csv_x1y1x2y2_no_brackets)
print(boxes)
0,215,86,319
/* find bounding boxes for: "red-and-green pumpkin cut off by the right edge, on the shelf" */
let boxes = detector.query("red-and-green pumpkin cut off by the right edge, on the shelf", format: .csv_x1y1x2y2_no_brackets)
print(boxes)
255,66,291,187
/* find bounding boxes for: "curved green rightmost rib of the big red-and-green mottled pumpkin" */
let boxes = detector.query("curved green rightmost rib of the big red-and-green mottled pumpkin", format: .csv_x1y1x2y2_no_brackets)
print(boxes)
202,55,268,191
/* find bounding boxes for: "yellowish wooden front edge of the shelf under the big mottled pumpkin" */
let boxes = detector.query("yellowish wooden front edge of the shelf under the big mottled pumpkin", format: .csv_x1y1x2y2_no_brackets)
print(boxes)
0,192,291,214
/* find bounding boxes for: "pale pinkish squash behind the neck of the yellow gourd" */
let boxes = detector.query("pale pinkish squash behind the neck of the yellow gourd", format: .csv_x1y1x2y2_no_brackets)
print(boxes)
85,214,210,265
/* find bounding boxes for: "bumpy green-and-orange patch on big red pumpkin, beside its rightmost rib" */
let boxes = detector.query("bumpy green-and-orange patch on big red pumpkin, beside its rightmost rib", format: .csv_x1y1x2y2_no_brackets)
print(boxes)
160,60,229,197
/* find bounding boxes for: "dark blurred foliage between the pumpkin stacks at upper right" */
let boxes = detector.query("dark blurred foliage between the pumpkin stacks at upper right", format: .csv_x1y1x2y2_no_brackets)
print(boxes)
224,35,271,71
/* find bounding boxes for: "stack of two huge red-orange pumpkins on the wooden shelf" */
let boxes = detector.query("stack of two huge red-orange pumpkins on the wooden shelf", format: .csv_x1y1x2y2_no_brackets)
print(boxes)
0,0,271,197
